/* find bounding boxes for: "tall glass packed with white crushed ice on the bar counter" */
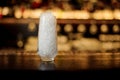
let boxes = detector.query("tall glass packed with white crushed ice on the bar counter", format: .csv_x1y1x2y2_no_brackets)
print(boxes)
38,11,57,61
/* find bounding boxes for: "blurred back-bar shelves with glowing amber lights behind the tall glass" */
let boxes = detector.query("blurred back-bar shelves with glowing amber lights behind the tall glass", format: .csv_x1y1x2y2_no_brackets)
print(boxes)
0,0,120,52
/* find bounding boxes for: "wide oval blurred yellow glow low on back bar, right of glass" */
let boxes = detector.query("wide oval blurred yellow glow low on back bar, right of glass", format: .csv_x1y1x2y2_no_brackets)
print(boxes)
72,38,101,51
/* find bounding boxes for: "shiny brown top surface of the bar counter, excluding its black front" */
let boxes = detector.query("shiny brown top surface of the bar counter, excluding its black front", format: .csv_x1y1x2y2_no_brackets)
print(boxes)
0,50,120,71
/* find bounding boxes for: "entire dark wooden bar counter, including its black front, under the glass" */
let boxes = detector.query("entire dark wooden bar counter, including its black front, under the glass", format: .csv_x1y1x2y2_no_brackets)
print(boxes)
0,50,120,80
